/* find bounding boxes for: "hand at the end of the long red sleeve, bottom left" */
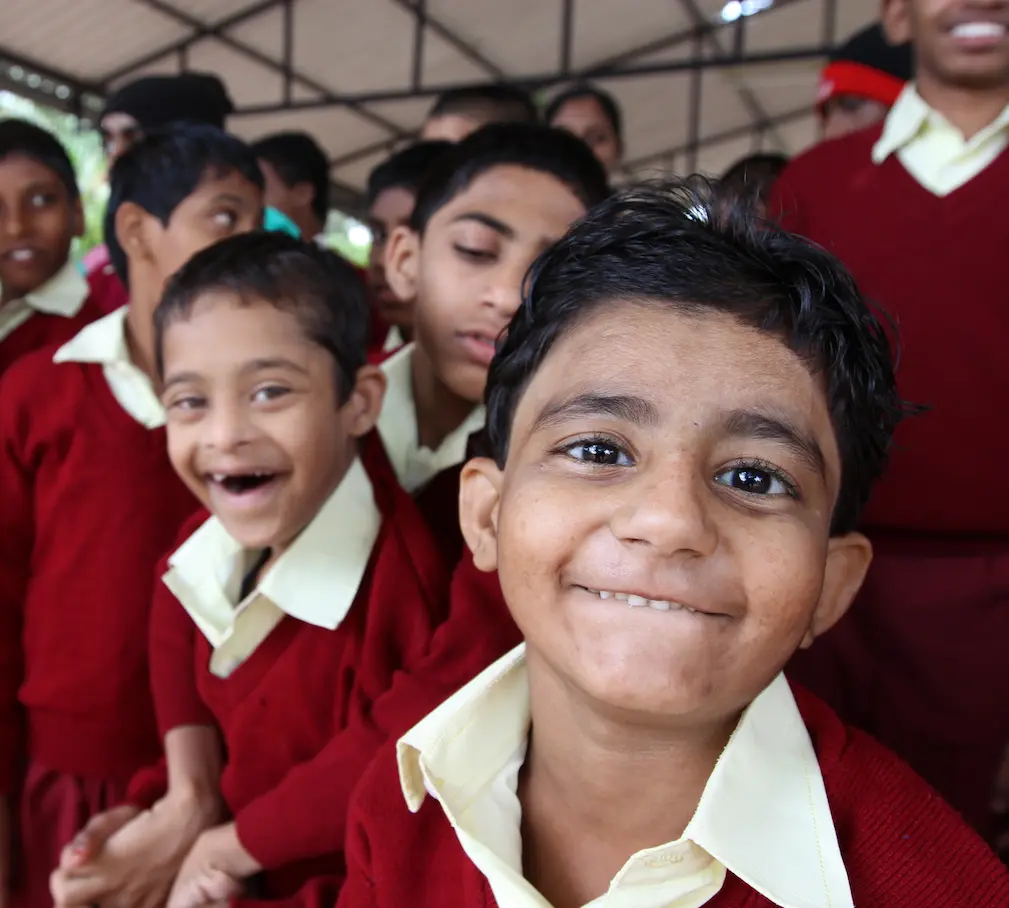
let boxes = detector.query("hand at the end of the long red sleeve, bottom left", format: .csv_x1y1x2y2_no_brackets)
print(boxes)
167,823,262,908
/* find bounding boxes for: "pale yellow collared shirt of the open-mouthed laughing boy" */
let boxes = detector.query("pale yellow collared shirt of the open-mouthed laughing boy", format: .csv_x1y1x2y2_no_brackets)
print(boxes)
162,460,381,678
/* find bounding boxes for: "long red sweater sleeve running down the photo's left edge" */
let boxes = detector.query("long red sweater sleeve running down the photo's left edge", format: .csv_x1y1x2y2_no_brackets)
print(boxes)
0,368,34,794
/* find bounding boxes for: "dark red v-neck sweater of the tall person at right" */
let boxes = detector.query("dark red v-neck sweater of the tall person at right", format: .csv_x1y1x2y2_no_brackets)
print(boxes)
769,127,1009,538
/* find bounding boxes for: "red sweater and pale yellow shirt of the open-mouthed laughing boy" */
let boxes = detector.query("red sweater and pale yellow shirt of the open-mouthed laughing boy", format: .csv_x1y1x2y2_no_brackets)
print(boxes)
124,435,461,904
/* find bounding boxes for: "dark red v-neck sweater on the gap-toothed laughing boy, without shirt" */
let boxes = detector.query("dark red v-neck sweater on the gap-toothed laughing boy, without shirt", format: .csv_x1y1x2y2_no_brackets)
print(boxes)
132,434,458,902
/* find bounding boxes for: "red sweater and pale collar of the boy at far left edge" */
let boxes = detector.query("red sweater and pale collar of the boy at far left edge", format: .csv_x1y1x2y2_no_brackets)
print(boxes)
0,261,104,375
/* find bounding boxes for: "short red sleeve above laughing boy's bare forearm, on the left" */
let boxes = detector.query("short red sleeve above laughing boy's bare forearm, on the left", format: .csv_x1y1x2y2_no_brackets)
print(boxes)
149,556,217,737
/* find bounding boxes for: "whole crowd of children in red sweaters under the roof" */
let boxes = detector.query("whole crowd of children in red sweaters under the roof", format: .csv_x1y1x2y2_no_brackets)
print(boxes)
0,0,1009,908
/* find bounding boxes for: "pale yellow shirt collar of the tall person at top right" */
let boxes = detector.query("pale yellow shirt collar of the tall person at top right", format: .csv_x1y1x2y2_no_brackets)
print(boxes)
873,85,1009,197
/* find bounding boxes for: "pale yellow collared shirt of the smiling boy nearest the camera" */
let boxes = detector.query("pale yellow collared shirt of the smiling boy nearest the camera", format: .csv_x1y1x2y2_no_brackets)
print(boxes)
398,646,854,908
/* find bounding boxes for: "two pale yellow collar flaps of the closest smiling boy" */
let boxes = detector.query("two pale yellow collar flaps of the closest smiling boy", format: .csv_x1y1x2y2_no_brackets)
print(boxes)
398,646,854,908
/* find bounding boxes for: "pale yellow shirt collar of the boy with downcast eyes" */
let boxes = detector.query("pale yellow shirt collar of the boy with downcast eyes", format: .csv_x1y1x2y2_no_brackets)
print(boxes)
378,344,485,494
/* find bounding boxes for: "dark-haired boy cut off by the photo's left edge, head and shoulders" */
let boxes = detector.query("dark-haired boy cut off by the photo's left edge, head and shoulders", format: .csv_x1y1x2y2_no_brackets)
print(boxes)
0,120,102,374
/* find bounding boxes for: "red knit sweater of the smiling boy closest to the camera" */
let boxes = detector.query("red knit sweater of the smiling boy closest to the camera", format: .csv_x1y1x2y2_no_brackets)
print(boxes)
337,690,1009,908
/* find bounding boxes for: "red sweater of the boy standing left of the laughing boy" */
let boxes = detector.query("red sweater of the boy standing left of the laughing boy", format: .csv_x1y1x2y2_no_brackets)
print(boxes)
0,348,197,792
